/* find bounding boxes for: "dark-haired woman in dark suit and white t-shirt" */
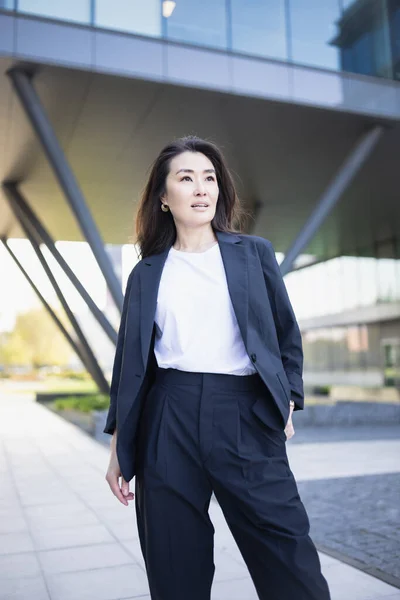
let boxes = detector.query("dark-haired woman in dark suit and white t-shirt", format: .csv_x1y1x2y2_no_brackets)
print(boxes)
104,137,330,600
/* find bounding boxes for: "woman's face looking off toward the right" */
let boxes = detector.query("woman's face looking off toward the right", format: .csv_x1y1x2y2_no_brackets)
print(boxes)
162,152,219,227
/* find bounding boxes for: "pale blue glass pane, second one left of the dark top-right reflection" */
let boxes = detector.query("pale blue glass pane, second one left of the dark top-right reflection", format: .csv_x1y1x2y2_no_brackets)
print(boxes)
231,0,288,60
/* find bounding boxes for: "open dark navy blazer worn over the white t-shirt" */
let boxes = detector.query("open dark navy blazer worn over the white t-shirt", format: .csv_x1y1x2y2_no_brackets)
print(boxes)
104,231,304,481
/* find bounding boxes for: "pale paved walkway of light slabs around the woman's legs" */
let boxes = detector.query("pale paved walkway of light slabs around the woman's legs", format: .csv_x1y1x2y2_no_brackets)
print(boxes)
0,394,400,600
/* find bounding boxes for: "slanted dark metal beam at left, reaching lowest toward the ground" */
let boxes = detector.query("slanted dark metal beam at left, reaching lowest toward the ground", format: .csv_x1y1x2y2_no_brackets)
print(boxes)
6,190,110,395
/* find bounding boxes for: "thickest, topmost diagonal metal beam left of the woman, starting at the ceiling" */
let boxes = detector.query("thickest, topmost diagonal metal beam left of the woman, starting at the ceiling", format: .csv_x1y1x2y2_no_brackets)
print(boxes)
7,67,123,313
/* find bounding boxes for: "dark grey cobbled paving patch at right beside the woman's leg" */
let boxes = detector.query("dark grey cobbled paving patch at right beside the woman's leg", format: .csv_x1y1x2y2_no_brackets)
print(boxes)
298,473,400,585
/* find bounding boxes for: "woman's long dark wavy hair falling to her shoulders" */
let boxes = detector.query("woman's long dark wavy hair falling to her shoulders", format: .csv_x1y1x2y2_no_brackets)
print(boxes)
136,136,248,258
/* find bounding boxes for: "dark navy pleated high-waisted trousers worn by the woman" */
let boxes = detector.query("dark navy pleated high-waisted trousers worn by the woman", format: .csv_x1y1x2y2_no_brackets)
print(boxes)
135,368,330,600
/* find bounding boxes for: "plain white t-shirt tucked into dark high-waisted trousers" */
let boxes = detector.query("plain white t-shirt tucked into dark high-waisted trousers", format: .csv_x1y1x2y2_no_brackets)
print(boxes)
154,243,256,375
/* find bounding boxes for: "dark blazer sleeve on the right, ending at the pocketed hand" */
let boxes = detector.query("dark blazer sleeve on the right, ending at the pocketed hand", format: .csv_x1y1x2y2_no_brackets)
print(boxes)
262,239,304,410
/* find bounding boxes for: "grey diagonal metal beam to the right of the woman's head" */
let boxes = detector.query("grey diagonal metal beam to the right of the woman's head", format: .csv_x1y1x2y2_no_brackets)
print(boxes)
280,125,384,275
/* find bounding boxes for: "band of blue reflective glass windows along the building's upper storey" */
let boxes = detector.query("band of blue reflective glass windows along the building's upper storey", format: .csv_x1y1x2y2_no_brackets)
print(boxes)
0,0,400,79
